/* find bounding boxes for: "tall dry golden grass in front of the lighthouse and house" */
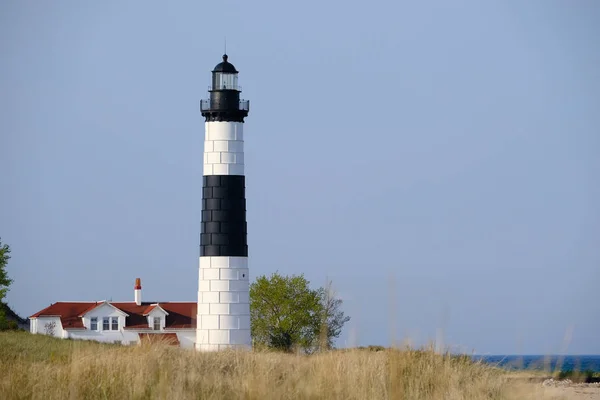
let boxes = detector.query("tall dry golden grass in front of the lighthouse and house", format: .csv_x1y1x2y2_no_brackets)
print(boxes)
0,332,552,400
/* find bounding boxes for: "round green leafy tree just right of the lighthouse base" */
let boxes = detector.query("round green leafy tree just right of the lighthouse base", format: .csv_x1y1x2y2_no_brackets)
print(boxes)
250,273,350,352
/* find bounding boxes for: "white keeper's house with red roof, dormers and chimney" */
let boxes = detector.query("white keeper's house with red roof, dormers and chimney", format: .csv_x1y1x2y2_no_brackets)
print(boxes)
29,278,198,348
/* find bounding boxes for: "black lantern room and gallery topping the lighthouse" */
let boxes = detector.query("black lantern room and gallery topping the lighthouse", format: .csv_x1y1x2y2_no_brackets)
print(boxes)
200,54,249,122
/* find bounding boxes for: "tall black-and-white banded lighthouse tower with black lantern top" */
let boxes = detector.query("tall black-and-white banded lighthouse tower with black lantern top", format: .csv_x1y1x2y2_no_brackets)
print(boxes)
196,55,251,351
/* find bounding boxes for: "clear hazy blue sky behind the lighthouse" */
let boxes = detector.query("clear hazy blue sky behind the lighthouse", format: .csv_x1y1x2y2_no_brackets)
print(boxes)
0,0,600,354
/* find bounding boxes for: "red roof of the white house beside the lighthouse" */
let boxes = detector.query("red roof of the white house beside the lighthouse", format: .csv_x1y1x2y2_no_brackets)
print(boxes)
30,301,198,329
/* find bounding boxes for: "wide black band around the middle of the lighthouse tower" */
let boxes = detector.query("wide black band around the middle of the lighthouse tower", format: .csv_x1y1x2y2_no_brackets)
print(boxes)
200,175,248,257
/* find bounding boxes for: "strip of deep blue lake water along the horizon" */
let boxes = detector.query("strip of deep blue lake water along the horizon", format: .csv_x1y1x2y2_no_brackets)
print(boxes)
473,355,600,372
